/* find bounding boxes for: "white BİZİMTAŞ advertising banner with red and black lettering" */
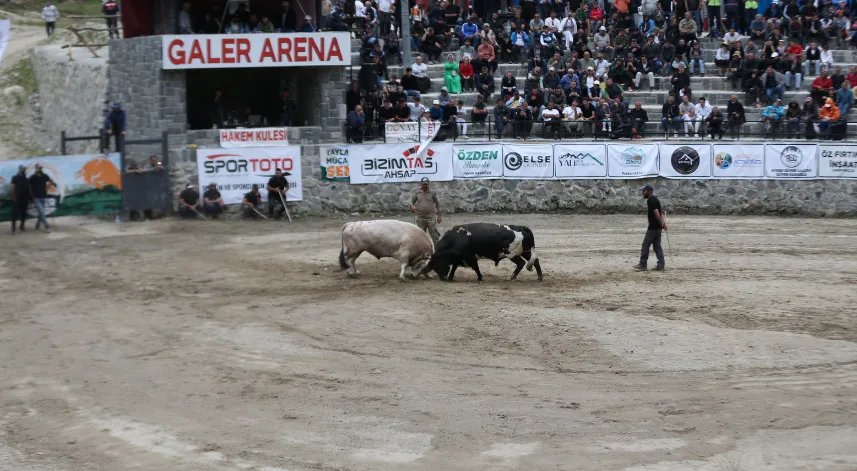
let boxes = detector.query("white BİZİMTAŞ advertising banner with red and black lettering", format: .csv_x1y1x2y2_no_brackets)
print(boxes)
348,143,452,184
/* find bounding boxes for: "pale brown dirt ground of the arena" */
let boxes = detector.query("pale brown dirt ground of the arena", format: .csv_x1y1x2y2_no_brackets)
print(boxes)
0,214,857,471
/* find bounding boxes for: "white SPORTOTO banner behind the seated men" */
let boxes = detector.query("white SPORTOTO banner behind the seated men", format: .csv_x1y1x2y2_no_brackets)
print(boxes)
196,146,303,204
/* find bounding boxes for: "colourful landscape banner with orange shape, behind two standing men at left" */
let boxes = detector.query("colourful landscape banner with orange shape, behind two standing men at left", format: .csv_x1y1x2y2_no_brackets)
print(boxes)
0,153,123,221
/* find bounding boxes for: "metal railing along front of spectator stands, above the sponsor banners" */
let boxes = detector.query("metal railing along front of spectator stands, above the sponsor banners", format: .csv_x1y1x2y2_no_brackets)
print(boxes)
345,117,857,143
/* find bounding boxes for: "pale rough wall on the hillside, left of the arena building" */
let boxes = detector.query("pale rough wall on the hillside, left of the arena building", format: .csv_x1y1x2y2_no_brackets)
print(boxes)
31,45,107,154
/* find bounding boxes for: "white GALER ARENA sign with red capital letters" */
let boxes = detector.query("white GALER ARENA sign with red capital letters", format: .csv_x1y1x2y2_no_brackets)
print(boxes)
162,32,351,69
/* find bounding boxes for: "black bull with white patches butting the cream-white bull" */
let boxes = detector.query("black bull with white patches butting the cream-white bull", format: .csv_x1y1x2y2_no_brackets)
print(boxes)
422,223,542,281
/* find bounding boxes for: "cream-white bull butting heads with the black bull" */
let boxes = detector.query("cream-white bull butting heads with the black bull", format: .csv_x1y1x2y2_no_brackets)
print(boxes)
339,219,434,280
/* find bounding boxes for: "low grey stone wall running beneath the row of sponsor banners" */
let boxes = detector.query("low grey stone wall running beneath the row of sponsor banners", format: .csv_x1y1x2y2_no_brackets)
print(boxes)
171,133,857,217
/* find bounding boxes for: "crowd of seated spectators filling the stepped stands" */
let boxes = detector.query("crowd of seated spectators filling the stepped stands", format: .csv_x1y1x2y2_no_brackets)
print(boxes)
346,0,857,138
